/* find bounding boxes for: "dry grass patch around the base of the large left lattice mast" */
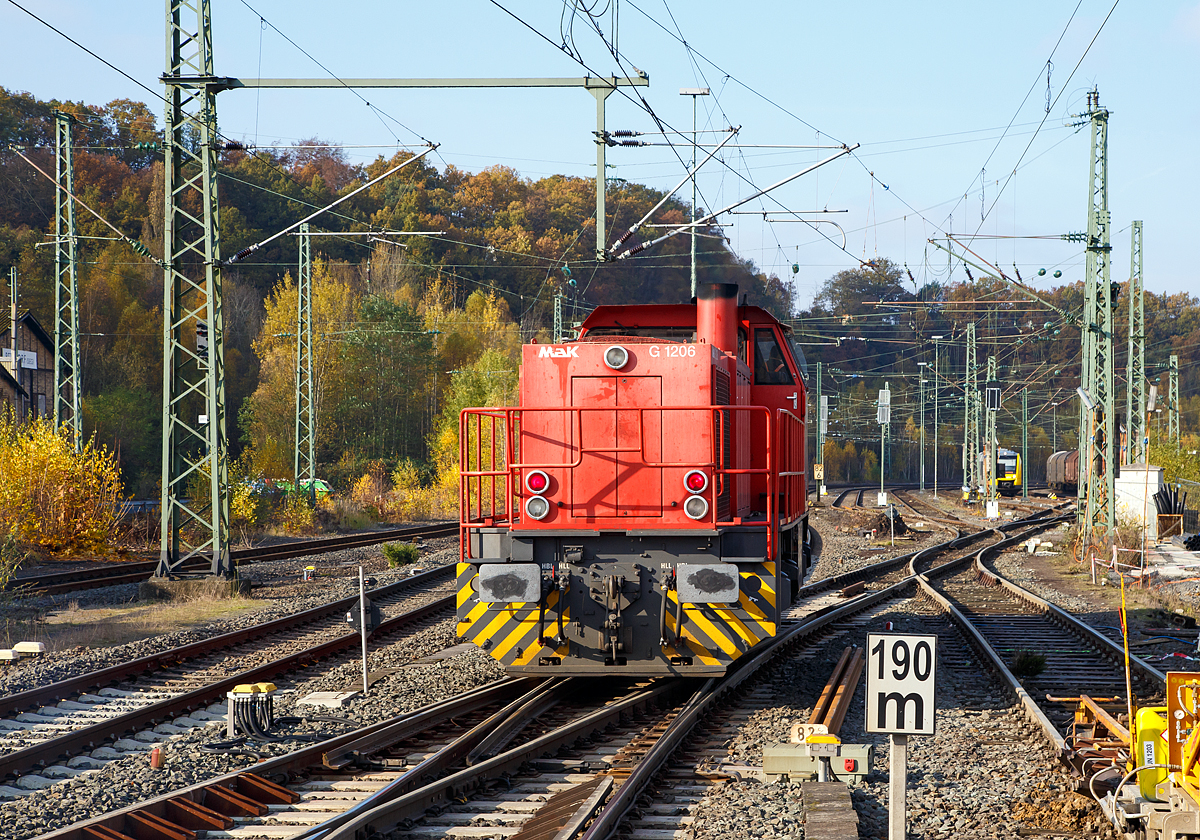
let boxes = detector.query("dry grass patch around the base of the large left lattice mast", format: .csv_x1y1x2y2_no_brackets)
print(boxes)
5,598,271,650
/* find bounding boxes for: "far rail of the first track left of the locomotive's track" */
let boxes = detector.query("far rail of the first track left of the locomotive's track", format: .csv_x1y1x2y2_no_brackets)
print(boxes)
0,565,455,716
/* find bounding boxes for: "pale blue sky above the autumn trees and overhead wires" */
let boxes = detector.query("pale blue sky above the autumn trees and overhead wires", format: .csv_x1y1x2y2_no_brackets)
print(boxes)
0,0,1200,304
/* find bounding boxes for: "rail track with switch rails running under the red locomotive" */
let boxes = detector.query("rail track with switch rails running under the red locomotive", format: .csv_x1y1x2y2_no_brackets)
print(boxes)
25,514,1099,840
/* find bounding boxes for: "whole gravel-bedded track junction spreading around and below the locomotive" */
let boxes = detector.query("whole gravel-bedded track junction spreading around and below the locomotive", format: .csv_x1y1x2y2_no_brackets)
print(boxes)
0,488,1200,840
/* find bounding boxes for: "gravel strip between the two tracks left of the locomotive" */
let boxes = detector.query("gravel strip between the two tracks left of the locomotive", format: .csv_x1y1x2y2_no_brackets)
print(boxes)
0,538,458,695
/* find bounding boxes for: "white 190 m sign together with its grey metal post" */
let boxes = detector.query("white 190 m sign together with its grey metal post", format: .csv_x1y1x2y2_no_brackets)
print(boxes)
865,632,937,840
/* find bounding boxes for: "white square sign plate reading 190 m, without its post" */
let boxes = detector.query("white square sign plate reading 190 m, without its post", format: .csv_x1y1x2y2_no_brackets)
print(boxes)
865,632,937,734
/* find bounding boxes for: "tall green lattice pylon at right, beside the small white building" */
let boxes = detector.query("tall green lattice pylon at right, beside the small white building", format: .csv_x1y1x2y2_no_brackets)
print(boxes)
1079,89,1120,542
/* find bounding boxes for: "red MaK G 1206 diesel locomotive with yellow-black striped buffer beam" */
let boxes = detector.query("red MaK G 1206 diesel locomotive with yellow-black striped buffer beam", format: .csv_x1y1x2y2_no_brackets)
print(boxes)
457,283,808,677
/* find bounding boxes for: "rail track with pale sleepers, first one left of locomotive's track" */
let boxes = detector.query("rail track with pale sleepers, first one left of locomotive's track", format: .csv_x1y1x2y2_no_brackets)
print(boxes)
0,566,455,779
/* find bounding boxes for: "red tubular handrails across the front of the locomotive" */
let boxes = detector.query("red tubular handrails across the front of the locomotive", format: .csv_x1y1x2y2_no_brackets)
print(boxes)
458,406,806,551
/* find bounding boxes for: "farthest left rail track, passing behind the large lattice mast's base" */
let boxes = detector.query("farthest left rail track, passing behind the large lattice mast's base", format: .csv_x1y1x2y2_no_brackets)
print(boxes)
4,522,458,595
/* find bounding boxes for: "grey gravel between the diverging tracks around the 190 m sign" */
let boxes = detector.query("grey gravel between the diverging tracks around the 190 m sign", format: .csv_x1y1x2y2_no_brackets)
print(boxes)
691,518,1115,840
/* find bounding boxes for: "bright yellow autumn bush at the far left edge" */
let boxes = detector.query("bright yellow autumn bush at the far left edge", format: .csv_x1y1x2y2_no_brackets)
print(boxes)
0,413,121,552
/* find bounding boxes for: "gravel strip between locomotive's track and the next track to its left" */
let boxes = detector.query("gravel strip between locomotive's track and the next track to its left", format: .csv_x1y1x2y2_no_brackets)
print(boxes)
0,618,504,840
